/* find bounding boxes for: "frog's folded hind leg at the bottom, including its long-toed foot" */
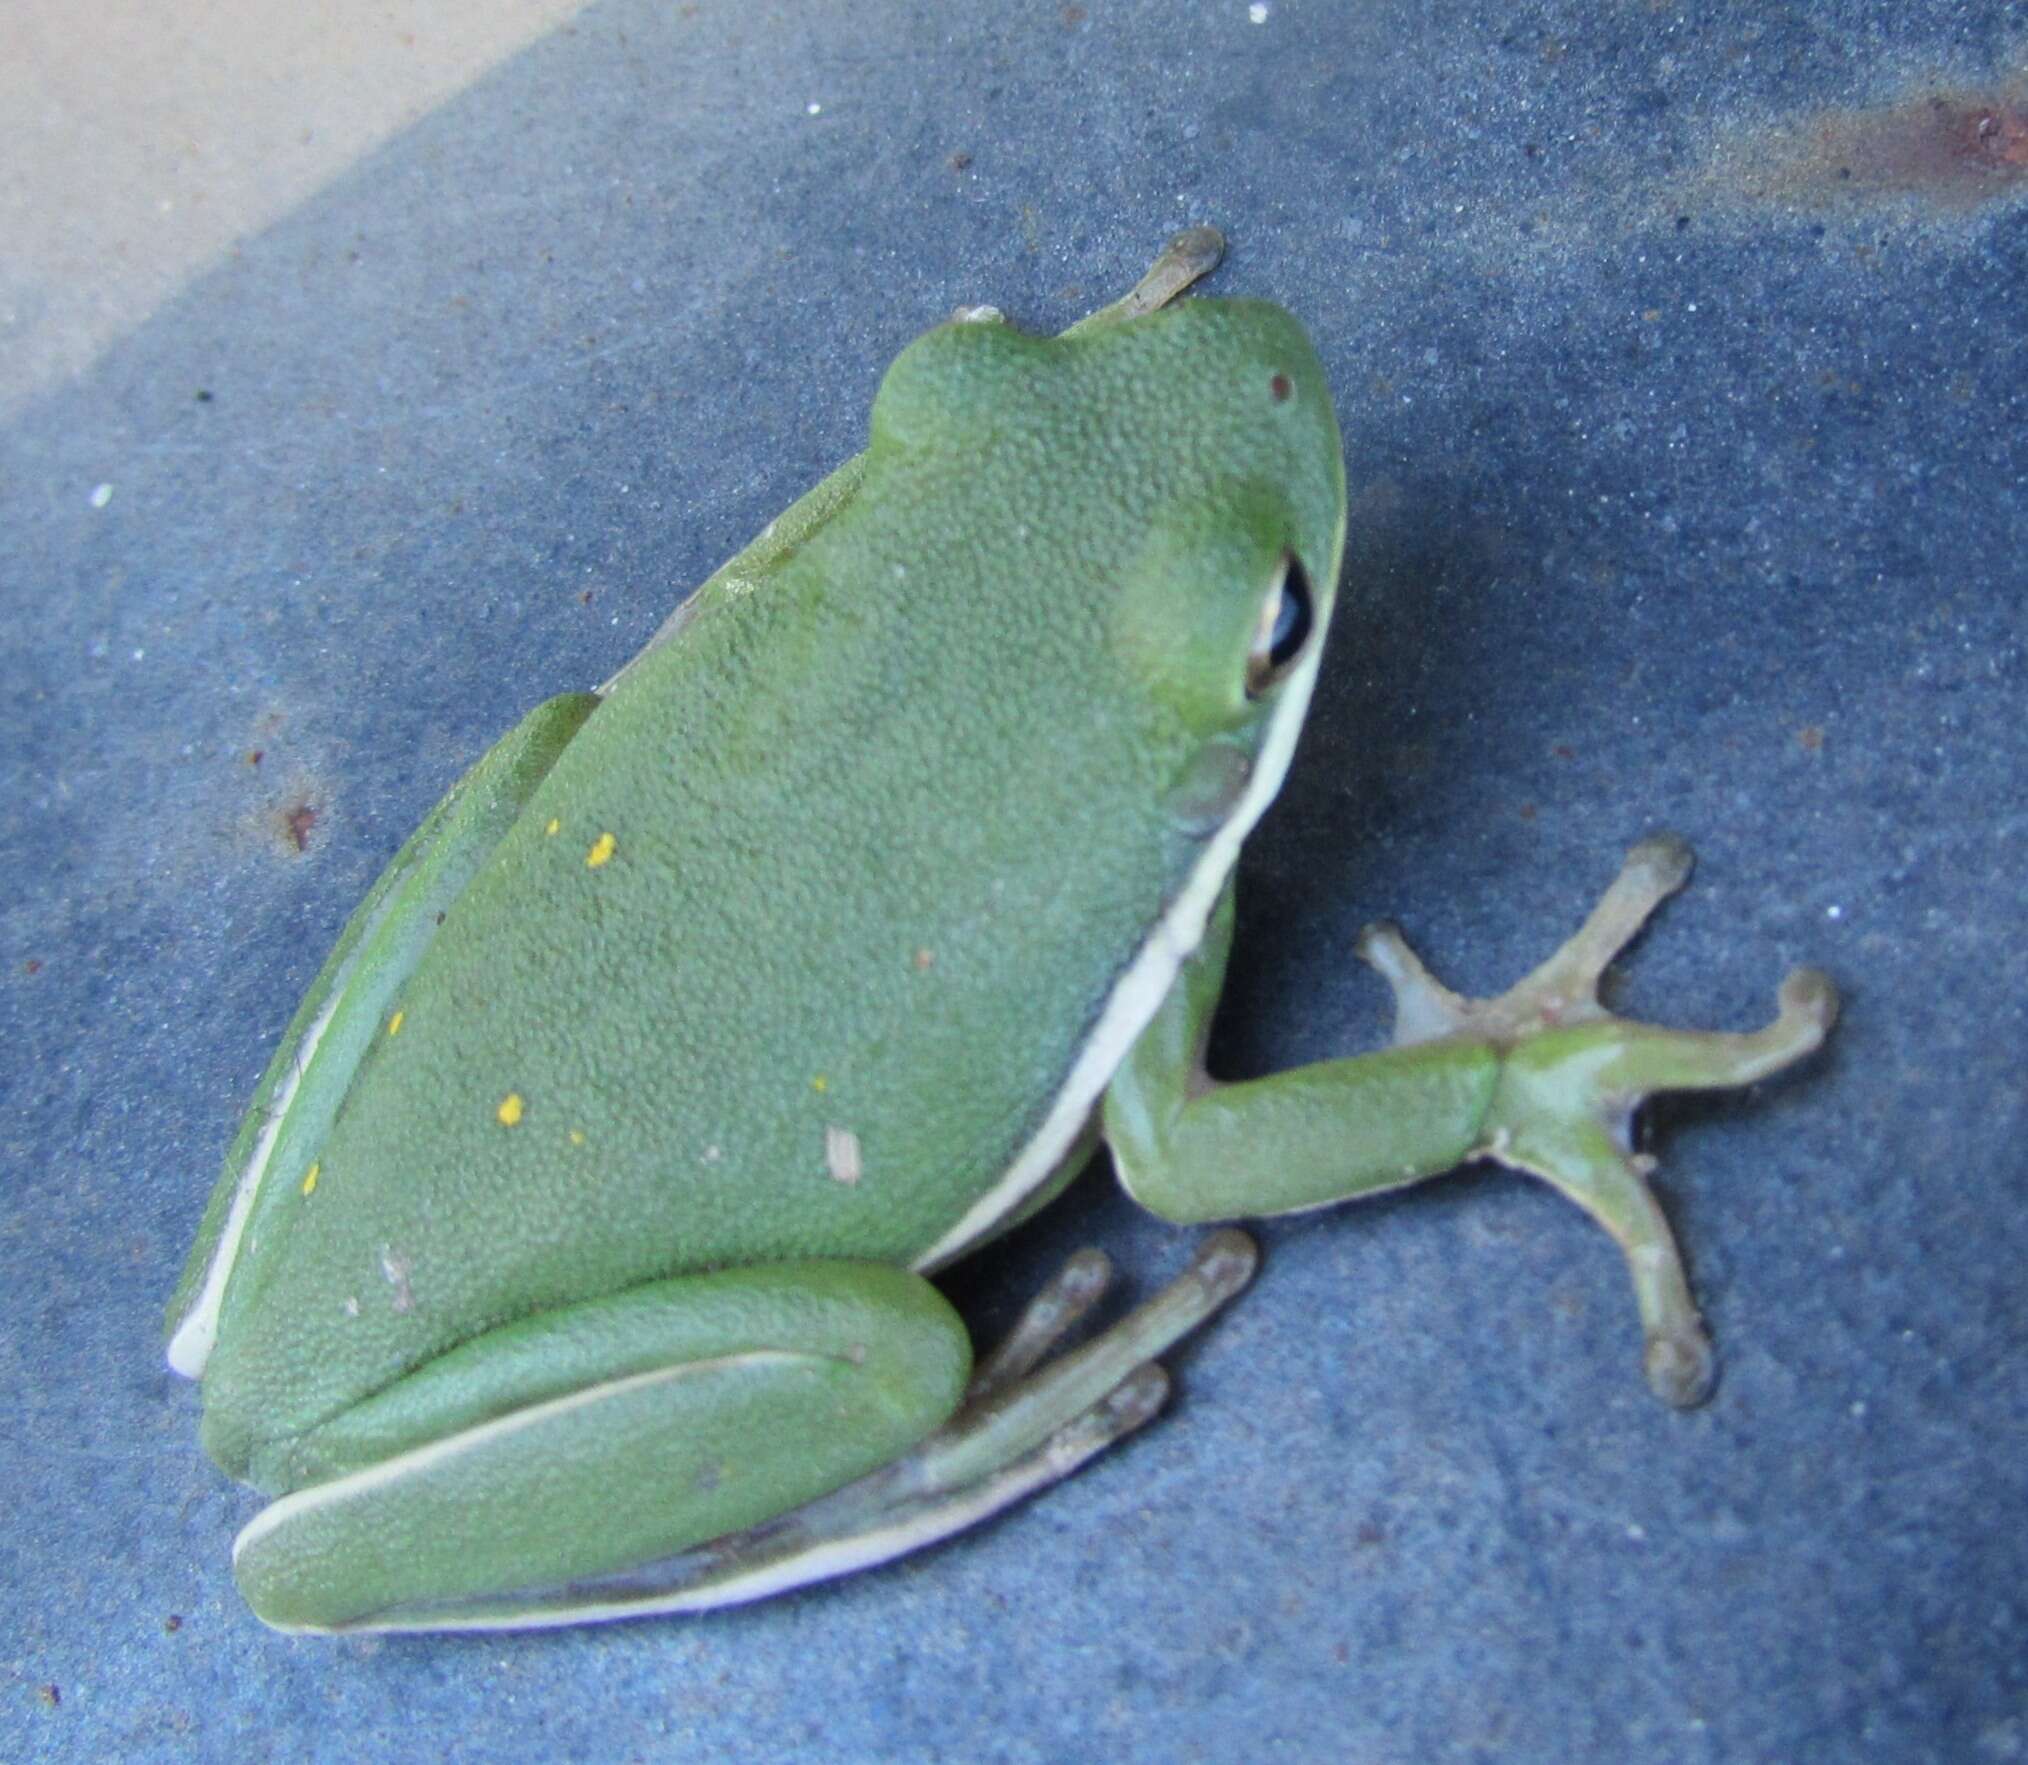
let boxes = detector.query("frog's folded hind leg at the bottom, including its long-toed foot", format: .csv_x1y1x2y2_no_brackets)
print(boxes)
233,1233,1253,1631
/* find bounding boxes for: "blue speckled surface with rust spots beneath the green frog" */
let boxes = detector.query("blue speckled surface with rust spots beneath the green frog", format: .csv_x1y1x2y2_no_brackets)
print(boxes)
0,0,2028,1761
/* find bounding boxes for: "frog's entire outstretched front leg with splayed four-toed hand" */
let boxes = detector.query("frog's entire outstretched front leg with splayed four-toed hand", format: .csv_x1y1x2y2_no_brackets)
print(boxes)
1105,838,1837,1406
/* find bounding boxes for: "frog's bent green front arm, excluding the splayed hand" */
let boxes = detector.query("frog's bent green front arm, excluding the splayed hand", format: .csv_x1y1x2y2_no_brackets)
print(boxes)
1105,883,1501,1223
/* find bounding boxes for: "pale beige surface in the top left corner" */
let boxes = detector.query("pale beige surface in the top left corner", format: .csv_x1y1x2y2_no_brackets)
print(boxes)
0,0,584,414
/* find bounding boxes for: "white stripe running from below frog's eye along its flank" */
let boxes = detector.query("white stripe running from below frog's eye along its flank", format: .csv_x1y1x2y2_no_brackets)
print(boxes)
911,633,1324,1274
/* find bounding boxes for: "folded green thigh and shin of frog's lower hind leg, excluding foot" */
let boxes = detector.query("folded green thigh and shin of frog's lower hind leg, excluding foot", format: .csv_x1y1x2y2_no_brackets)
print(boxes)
233,1262,971,1629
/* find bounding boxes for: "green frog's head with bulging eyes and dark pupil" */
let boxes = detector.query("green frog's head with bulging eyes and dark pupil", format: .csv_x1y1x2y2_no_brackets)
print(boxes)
872,300,1345,872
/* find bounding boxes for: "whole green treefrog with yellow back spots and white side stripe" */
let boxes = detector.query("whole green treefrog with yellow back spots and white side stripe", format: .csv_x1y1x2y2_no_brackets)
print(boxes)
168,229,1833,1631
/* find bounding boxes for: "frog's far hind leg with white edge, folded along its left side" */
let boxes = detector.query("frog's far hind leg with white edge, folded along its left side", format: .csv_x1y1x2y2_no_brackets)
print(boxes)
166,692,598,1378
